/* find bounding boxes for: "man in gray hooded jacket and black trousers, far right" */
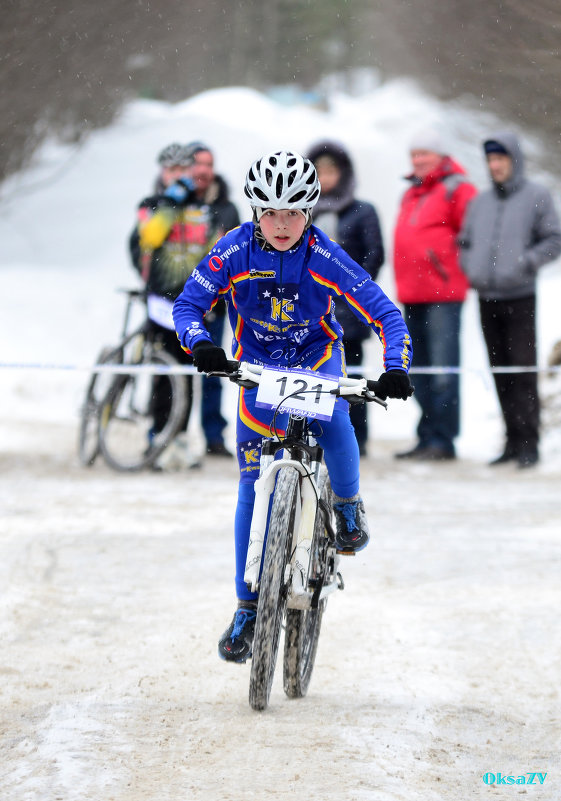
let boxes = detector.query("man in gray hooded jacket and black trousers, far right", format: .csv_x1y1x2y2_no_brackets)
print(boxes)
460,133,561,467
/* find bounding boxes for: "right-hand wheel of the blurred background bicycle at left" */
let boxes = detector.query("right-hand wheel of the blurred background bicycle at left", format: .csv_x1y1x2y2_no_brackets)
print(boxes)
99,350,191,472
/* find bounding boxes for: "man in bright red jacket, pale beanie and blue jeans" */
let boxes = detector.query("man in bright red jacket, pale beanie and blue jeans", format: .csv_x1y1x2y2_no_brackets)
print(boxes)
394,128,475,461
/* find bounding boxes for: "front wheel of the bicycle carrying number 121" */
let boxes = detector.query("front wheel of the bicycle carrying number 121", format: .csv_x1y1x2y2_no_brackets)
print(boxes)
249,467,299,710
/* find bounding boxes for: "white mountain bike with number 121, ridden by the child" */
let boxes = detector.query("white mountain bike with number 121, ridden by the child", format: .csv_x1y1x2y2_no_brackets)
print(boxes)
211,362,387,711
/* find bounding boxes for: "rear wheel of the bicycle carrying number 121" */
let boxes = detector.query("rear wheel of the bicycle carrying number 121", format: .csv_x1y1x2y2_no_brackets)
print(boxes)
283,472,331,698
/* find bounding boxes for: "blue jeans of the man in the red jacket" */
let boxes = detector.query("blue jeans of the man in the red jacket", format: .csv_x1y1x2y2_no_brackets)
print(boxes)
404,303,462,453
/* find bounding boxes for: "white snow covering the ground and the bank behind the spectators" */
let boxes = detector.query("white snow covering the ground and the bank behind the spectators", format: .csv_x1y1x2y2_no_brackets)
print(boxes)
0,82,561,801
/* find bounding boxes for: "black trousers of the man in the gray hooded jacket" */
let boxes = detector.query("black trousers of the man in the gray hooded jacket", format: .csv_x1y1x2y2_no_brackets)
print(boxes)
479,295,540,455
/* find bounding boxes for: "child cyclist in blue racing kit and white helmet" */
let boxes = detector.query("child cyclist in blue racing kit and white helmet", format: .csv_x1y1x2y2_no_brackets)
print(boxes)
173,151,412,662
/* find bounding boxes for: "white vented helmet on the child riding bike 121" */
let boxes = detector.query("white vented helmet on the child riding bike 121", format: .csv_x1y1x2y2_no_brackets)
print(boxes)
244,150,320,211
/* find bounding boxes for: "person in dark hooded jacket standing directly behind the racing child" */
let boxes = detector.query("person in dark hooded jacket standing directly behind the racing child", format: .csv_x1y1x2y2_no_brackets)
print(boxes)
308,141,384,456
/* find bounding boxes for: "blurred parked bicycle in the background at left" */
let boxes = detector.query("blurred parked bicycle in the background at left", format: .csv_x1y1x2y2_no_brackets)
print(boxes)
78,289,192,472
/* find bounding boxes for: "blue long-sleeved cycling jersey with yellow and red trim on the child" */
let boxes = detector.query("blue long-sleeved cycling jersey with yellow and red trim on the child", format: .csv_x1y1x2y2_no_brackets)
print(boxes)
173,222,412,371
